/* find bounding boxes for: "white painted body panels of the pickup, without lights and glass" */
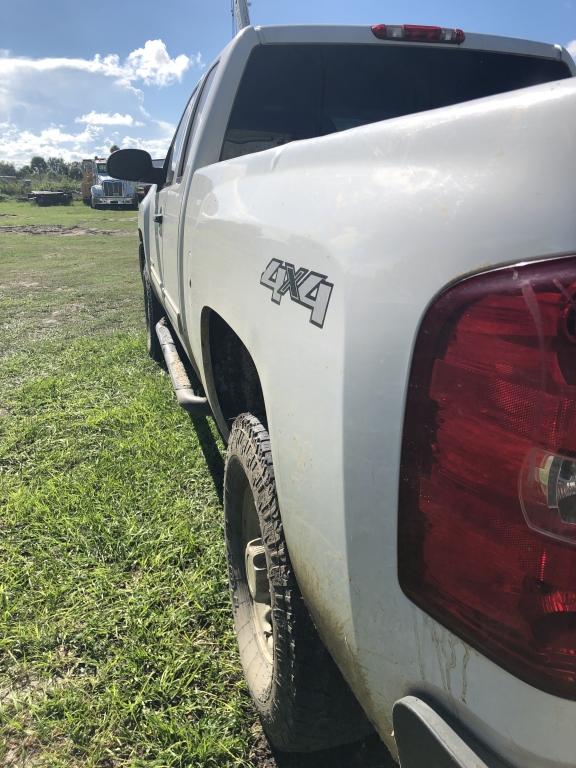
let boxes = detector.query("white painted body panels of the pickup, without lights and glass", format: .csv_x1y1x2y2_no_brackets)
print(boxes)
140,27,576,768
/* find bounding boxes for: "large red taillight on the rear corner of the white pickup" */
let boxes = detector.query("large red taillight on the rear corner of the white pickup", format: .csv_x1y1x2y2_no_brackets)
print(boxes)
398,257,576,699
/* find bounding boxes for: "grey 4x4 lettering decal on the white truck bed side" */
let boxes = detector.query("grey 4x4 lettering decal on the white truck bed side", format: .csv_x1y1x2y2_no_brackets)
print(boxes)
260,259,334,328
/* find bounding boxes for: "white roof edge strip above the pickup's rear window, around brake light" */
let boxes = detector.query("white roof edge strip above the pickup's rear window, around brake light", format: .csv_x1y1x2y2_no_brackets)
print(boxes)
250,22,576,63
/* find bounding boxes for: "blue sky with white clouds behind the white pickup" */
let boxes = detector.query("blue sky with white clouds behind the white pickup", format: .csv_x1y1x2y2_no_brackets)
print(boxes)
0,0,576,165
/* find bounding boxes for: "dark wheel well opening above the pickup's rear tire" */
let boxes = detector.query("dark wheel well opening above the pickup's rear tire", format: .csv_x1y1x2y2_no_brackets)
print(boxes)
204,310,268,429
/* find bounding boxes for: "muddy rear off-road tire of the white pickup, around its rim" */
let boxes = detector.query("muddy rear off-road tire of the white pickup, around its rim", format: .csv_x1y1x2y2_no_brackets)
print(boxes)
224,414,372,753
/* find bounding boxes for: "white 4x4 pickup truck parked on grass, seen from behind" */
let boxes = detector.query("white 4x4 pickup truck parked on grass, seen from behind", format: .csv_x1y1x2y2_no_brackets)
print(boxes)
108,24,576,768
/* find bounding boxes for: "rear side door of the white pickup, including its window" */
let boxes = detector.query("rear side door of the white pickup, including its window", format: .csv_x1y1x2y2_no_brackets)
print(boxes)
155,67,215,331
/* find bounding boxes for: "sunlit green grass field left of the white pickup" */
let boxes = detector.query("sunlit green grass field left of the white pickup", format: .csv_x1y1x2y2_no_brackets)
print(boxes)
0,202,257,767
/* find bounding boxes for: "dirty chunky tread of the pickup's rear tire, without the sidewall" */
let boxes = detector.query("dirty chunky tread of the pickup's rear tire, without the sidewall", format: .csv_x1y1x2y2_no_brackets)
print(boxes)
225,413,372,752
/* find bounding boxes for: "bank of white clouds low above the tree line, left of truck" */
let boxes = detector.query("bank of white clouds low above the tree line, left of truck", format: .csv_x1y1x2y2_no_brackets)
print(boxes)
0,40,199,165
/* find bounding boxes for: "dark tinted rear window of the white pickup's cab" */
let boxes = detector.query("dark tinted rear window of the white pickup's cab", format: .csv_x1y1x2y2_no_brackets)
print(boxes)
221,44,571,160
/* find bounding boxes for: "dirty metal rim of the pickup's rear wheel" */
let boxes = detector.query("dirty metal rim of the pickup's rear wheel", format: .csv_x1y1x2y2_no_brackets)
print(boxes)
242,486,274,664
